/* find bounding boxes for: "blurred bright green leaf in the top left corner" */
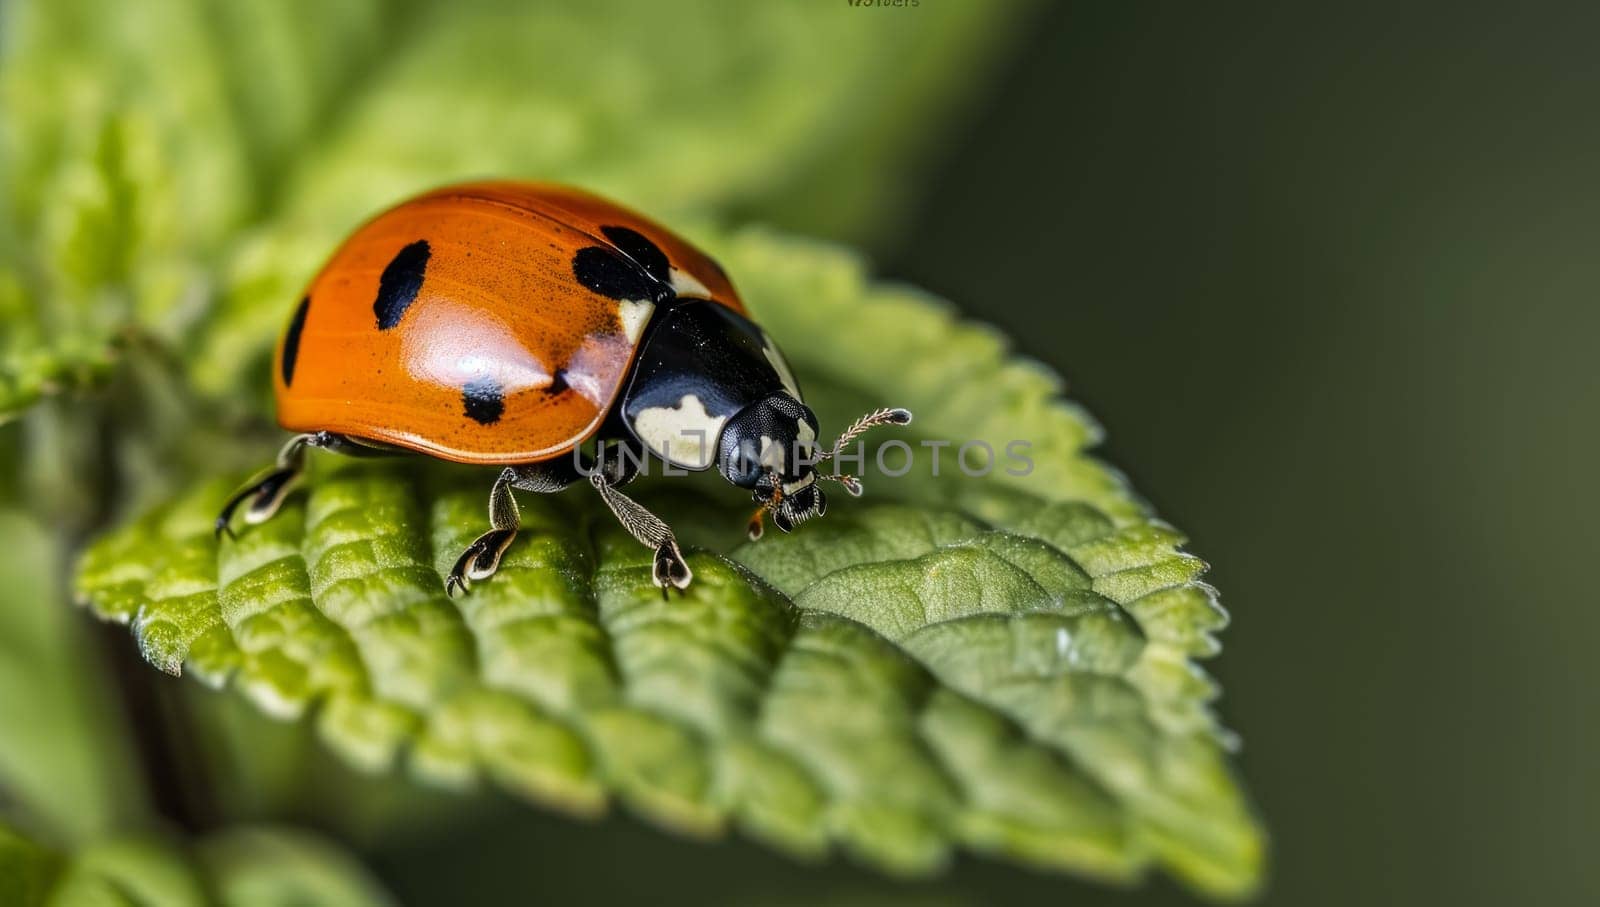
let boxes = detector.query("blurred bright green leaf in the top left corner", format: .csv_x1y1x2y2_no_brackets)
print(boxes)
0,0,251,419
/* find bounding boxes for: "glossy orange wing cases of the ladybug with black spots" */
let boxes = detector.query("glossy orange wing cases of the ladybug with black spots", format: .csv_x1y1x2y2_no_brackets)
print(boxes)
274,182,744,464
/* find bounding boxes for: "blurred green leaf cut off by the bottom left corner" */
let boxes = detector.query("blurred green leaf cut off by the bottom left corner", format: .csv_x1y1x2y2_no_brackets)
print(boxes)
0,825,390,907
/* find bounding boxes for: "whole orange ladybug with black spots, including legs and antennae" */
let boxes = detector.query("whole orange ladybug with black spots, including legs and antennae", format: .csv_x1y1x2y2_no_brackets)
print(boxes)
216,182,910,595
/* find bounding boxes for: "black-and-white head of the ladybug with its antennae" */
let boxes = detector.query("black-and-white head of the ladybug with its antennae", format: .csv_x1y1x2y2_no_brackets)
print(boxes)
717,394,910,539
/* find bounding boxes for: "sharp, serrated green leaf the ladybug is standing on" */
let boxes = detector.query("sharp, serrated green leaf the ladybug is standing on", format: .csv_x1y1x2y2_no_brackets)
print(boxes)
78,232,1262,894
